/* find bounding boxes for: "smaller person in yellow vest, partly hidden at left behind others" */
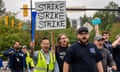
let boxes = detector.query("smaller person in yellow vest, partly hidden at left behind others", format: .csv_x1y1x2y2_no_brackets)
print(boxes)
22,45,34,72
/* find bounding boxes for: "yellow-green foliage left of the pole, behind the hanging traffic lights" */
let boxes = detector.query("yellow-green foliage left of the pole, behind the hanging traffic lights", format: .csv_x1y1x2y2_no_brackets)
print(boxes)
0,16,31,51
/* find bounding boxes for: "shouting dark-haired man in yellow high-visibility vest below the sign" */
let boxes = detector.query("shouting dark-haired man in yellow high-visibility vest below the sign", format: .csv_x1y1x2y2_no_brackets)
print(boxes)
34,37,59,72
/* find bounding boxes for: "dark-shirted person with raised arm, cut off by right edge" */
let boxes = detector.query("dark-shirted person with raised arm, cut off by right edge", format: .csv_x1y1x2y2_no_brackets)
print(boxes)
112,34,120,72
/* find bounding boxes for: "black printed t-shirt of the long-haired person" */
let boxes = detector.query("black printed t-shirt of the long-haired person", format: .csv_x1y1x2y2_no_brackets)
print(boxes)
56,47,68,72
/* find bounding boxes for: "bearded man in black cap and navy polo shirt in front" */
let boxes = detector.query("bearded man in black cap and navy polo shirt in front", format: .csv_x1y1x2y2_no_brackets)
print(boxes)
63,27,103,72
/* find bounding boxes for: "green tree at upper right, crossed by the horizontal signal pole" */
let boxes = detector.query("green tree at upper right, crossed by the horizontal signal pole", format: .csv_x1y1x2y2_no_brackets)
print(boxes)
94,1,118,31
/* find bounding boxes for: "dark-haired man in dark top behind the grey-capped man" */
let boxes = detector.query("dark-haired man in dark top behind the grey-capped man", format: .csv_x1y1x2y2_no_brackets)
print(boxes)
102,31,113,55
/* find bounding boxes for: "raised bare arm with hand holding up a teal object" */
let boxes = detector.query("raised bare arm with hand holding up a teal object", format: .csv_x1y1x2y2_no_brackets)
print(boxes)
92,17,101,36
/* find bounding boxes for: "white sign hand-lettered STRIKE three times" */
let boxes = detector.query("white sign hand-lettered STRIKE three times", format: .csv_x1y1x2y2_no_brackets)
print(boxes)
35,1,66,30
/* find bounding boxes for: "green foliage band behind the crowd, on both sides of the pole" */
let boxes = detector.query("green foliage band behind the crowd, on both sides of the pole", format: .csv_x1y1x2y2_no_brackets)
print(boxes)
0,12,76,51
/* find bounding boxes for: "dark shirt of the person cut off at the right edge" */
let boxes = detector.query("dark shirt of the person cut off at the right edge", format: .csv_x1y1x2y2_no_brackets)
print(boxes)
113,45,120,71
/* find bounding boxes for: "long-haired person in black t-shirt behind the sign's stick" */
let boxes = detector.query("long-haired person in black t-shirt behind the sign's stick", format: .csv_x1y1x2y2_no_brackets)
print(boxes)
55,33,69,72
